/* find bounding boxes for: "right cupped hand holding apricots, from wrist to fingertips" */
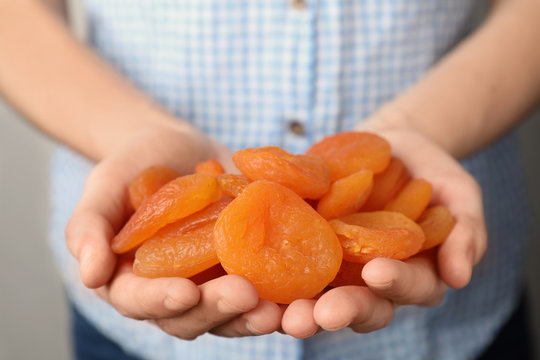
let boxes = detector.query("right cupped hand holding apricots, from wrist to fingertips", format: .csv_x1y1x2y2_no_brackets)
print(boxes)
282,120,487,338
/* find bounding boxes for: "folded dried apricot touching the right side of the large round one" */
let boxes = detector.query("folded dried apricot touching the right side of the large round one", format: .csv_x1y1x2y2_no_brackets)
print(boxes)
330,211,425,264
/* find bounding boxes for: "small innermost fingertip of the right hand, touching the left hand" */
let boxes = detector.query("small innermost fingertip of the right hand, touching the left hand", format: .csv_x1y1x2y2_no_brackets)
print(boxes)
281,299,319,339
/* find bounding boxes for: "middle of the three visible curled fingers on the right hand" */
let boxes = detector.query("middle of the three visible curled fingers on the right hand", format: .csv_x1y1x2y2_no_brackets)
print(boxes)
313,286,394,333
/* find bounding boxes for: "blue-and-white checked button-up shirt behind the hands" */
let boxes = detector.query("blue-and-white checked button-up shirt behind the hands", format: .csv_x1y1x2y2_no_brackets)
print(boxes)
51,0,527,360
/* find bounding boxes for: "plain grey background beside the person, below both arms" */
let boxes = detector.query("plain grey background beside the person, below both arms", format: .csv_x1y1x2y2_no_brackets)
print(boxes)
0,98,540,360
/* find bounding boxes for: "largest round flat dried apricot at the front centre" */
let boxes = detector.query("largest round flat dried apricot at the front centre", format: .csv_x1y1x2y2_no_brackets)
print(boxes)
214,180,342,304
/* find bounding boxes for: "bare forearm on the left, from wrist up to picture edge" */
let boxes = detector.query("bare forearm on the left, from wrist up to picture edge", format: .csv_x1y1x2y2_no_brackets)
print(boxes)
0,0,193,160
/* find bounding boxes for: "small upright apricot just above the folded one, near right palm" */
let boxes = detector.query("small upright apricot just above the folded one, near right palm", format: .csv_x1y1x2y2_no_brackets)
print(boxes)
384,179,433,220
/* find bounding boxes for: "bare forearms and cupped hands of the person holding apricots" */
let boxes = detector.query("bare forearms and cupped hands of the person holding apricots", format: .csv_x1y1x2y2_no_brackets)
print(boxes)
0,0,540,339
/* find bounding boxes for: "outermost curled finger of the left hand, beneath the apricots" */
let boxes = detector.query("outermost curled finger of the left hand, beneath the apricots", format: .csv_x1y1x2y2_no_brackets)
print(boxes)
103,261,200,320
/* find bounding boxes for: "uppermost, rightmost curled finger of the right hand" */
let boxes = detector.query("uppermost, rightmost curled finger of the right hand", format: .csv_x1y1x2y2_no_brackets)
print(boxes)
362,254,447,306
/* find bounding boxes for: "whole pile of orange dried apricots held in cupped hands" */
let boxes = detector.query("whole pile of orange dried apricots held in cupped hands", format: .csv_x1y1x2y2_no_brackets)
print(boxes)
111,131,454,304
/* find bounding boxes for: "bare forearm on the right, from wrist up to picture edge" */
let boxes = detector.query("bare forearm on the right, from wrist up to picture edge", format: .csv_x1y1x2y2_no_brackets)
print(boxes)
364,0,540,157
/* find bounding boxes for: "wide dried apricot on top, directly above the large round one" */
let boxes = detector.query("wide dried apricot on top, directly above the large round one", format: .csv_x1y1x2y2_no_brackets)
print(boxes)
233,146,330,199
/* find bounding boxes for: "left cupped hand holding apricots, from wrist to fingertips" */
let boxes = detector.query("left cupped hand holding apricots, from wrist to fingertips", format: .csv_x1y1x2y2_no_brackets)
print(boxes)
66,124,282,339
